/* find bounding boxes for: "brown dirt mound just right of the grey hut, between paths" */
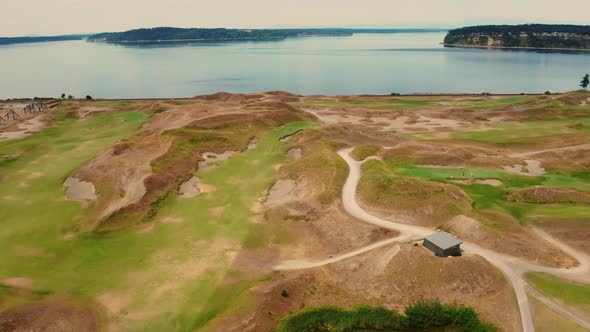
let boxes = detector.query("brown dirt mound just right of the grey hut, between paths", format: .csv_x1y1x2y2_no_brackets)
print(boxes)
445,215,578,267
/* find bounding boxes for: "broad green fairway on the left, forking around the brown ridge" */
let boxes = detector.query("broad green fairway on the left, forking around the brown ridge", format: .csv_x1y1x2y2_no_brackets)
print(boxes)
0,110,312,331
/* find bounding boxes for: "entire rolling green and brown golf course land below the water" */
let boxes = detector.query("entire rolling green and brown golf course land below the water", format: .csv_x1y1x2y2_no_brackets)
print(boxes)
0,91,590,332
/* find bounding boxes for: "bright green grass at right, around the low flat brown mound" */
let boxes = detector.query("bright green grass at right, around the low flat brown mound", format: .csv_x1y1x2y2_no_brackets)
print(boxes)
389,163,590,223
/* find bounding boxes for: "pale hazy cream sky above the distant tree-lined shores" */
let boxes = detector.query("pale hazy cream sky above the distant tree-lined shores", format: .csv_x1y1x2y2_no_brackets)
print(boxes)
0,0,590,36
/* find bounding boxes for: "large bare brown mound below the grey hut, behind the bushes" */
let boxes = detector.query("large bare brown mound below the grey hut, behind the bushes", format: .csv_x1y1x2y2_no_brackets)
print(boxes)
218,244,520,331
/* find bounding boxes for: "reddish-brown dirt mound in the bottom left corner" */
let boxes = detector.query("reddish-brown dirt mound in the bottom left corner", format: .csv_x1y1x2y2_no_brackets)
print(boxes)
0,301,99,332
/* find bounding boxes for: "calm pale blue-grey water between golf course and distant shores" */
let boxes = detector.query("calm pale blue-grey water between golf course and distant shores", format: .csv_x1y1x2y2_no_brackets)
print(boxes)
0,33,590,98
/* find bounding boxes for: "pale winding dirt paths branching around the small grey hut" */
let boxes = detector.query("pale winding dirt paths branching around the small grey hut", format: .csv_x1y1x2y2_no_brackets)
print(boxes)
275,148,590,332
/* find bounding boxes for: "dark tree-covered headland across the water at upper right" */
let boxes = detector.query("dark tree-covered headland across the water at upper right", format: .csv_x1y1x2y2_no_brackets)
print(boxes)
444,24,590,51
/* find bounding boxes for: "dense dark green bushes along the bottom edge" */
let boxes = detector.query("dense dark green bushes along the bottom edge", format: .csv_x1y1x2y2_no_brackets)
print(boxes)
278,301,496,332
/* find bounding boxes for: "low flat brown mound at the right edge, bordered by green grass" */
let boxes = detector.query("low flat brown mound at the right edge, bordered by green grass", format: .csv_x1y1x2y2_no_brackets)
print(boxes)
508,186,590,203
